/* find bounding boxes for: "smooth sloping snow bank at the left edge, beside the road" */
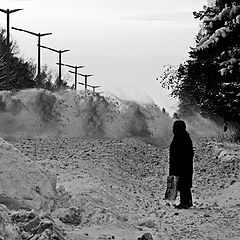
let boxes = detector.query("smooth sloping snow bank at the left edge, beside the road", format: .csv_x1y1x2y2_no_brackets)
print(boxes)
0,138,56,211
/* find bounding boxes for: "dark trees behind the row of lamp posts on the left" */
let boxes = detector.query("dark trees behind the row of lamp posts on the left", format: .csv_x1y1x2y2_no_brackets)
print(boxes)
0,29,70,91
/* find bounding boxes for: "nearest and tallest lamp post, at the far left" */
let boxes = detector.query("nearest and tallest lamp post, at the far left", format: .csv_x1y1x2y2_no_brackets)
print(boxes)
0,8,23,90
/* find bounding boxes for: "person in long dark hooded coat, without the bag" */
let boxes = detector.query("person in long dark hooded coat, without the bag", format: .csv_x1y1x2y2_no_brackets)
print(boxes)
169,120,194,209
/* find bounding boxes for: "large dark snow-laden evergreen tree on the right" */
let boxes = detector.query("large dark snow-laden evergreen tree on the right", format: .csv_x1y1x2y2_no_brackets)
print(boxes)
161,0,240,122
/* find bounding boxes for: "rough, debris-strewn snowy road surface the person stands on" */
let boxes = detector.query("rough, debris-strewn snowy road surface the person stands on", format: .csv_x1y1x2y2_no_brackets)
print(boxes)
9,138,240,240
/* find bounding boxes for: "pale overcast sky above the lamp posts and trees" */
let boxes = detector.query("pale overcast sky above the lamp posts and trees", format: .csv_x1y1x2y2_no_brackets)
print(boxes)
0,0,206,112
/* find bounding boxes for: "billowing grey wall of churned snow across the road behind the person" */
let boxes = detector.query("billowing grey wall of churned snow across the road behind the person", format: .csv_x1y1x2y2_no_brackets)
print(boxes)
0,89,172,141
